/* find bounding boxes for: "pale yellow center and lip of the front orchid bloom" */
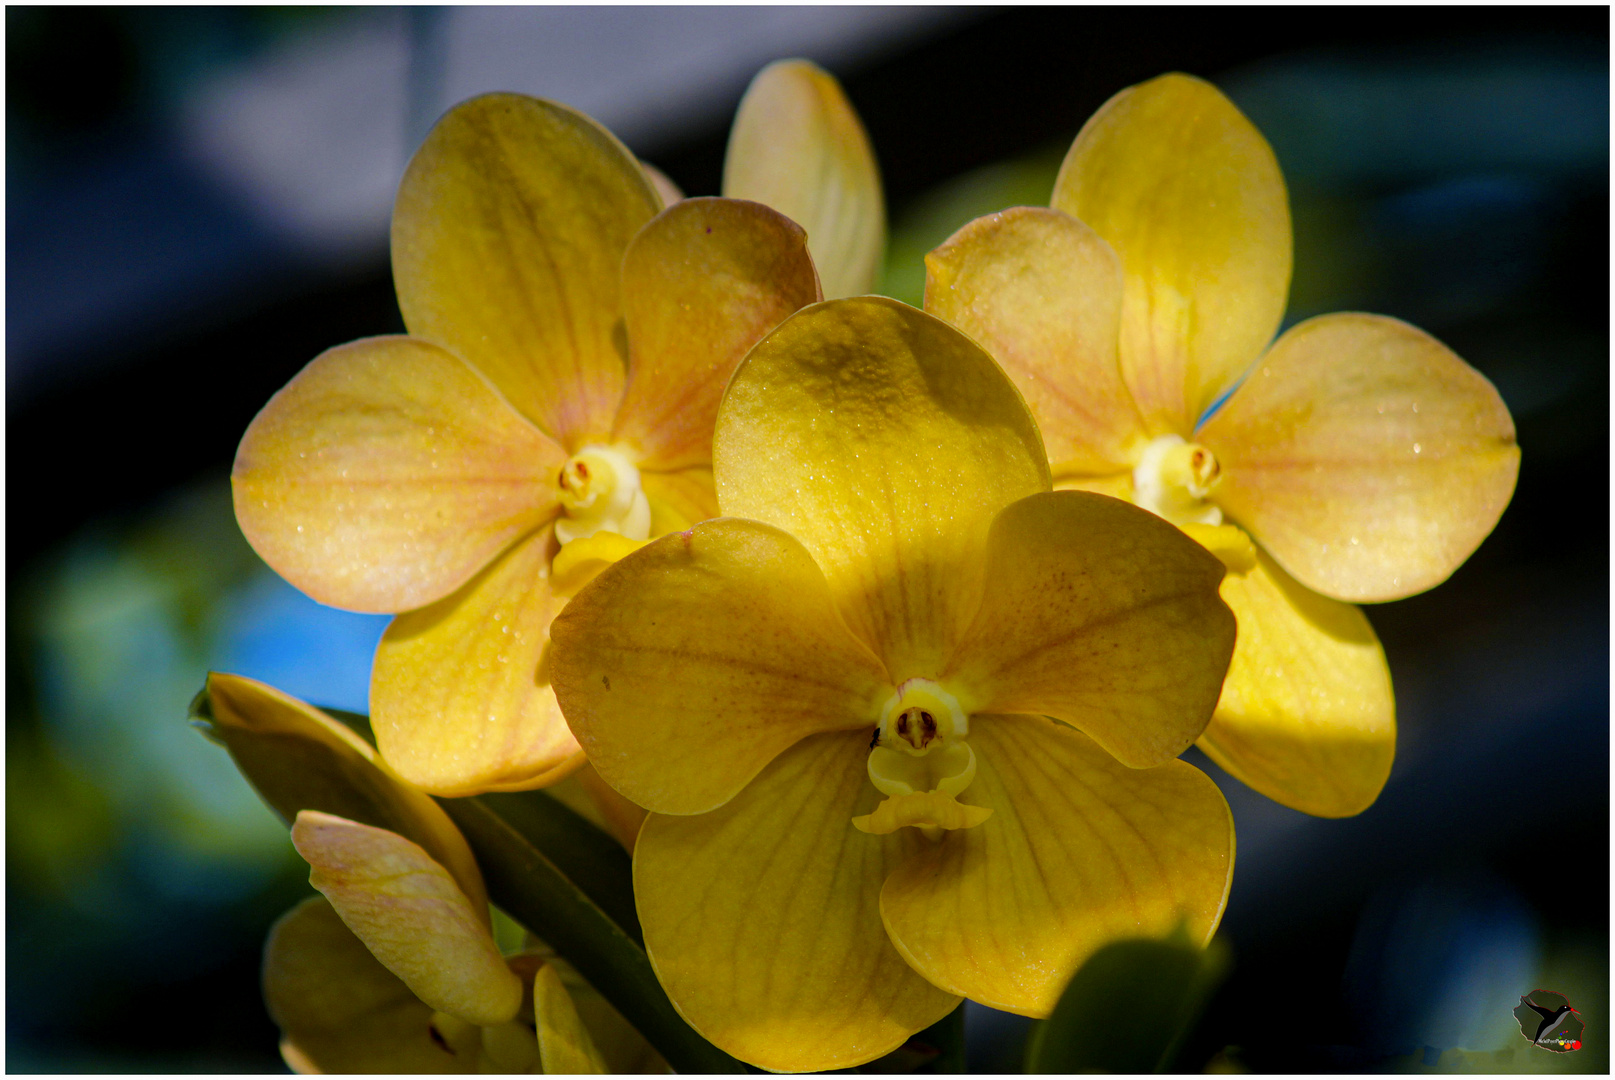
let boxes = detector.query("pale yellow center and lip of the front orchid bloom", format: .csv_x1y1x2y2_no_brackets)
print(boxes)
853,678,992,839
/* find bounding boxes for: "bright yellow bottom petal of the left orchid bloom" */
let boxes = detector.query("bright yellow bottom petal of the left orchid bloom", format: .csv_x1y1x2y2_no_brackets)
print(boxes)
370,530,580,796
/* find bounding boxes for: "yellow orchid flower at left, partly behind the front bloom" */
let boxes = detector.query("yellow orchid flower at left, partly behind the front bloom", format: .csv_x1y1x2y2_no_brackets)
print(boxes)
233,94,819,794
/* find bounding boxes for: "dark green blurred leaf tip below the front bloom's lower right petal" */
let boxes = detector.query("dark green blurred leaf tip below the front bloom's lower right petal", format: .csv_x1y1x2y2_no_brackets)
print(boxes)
1026,940,1227,1072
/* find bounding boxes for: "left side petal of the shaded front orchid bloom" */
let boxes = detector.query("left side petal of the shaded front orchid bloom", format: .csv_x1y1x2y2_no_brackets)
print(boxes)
551,518,890,814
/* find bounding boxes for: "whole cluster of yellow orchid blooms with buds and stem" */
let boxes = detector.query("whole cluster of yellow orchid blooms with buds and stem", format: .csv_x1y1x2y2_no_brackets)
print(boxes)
194,61,1518,1072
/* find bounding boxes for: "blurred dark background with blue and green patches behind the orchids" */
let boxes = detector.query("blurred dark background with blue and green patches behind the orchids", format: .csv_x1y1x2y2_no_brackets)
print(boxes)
6,6,1610,1072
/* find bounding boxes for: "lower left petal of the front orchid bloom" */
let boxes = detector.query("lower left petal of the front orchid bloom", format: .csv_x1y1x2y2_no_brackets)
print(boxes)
633,731,958,1072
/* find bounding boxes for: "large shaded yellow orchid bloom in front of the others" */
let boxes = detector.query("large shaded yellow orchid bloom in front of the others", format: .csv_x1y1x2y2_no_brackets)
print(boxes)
551,297,1234,1070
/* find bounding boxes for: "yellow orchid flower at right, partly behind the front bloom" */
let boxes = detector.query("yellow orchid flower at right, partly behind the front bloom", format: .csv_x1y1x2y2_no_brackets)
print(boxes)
925,74,1520,817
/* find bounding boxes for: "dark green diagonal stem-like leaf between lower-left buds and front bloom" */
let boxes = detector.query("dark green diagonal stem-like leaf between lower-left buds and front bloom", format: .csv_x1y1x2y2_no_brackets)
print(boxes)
439,796,746,1072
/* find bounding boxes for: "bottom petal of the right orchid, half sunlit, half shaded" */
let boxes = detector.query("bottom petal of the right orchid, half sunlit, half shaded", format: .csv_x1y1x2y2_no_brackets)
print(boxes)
1200,549,1397,817
